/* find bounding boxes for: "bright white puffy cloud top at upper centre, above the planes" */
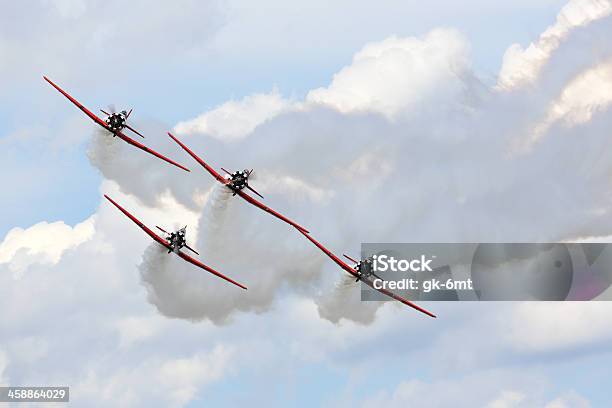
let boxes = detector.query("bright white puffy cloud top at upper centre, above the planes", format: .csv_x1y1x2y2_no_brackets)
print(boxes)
306,29,469,118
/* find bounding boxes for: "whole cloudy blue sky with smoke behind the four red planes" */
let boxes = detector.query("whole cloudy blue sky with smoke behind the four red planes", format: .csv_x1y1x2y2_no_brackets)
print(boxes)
0,0,612,408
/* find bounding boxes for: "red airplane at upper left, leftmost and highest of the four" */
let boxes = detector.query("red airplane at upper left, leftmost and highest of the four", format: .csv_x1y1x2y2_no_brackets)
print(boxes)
43,76,189,171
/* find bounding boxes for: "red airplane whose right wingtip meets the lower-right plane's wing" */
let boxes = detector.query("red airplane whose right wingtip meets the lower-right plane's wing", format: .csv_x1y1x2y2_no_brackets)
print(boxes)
168,132,308,233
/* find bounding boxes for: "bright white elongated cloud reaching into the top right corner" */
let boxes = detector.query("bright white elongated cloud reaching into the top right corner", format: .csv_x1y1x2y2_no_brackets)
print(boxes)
498,0,612,90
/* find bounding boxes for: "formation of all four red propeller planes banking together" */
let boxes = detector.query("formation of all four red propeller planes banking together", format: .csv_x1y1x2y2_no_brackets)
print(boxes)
43,77,436,317
